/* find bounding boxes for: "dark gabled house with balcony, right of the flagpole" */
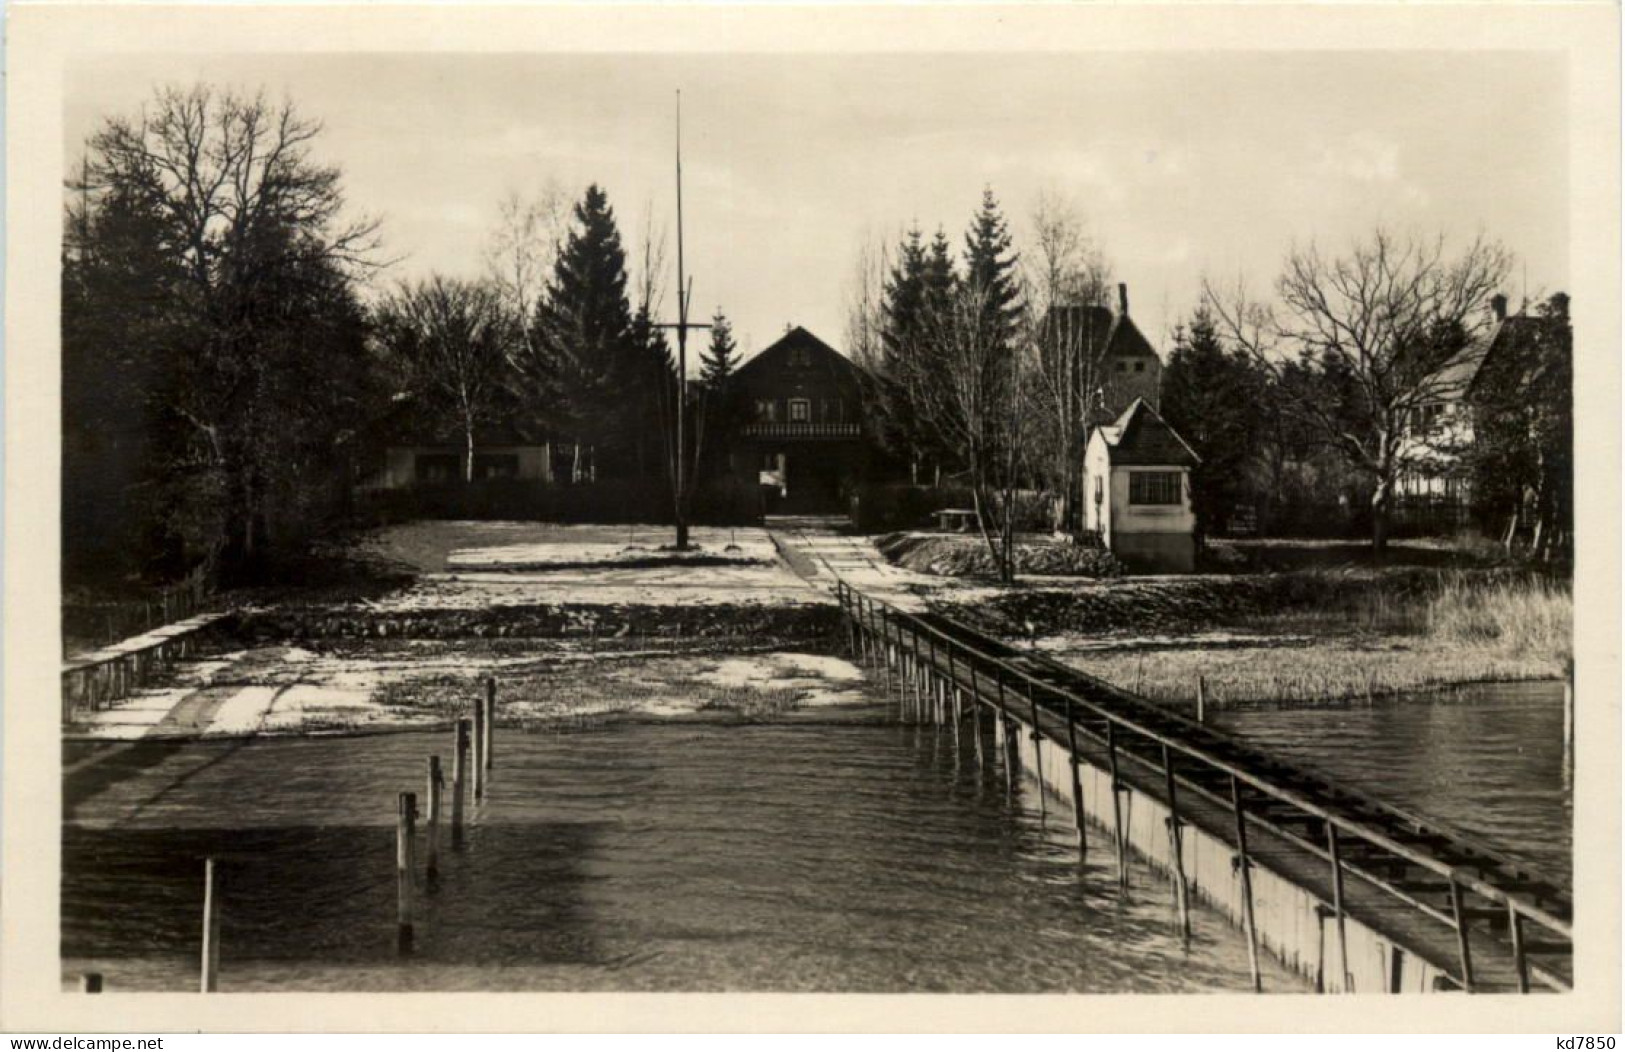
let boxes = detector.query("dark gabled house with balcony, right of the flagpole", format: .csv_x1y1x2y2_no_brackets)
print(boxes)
728,325,868,514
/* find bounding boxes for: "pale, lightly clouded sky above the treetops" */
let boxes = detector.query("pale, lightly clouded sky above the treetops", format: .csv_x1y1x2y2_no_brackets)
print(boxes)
65,52,1568,365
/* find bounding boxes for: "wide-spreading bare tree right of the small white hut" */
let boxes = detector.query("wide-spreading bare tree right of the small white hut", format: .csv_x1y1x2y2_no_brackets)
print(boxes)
1203,229,1511,551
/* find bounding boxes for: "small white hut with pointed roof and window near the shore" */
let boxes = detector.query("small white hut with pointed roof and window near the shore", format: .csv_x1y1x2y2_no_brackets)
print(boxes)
1084,398,1199,574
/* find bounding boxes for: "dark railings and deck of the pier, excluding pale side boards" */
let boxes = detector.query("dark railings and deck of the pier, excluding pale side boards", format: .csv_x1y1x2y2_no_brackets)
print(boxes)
835,580,1573,992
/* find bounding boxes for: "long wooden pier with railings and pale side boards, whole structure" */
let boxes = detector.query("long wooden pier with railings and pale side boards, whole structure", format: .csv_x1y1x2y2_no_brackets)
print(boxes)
835,582,1573,992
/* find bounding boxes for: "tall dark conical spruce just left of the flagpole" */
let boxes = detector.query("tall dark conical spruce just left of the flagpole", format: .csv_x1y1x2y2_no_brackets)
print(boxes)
523,184,642,480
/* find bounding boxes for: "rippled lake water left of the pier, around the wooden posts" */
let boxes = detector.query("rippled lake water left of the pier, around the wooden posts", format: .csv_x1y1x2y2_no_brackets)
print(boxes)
62,709,1303,992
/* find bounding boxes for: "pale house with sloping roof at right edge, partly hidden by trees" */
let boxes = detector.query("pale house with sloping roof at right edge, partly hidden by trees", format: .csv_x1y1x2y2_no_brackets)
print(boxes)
1394,293,1568,528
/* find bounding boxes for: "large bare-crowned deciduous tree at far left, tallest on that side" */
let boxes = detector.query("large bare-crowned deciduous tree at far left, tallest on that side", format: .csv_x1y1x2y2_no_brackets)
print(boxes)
81,85,384,561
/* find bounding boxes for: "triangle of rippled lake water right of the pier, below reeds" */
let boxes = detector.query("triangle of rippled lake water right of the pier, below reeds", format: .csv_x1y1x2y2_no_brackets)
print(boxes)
1214,683,1575,881
